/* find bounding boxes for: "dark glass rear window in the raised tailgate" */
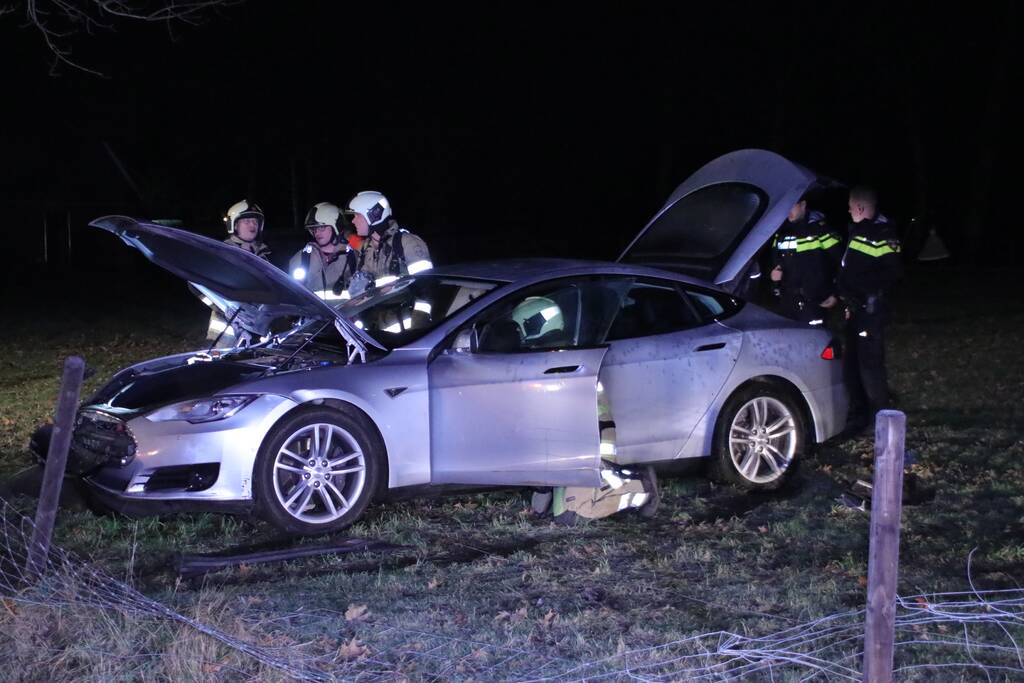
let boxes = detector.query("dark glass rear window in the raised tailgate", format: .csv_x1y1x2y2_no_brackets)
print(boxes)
627,182,767,262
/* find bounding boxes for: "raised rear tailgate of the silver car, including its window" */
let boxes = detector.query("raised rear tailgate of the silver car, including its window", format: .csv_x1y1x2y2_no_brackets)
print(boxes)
617,150,828,292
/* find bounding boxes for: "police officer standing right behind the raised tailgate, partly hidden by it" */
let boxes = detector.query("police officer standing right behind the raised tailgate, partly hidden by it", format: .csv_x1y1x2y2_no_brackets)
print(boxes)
769,197,842,325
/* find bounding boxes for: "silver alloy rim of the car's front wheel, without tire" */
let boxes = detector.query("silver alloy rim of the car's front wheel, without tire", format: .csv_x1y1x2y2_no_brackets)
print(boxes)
273,423,367,524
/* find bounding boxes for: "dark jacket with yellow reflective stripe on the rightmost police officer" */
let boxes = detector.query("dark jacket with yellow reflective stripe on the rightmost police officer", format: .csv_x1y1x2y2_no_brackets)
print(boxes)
837,215,903,312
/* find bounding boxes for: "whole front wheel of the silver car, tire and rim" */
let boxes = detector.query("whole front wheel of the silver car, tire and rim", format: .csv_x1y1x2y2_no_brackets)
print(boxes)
253,408,384,536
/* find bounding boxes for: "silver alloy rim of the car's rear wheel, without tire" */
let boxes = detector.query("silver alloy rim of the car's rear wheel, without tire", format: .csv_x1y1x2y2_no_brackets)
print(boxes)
729,396,798,484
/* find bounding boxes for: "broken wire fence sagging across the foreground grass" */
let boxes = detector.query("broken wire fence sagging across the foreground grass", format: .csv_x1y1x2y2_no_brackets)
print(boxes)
0,499,1024,683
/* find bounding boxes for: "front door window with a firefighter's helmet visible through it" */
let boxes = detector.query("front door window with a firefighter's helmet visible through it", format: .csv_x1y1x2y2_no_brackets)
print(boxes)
476,283,587,353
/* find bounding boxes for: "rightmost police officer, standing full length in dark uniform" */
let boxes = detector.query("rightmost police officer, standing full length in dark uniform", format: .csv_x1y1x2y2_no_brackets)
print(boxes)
837,186,903,434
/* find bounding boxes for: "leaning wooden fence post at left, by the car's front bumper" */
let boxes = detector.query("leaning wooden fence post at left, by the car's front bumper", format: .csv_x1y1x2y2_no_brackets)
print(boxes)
25,355,85,580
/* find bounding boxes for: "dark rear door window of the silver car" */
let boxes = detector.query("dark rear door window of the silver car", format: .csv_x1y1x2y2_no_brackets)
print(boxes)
605,281,702,342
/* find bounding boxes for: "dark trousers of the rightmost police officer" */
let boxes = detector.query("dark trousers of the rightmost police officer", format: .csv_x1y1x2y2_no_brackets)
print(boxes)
843,308,889,424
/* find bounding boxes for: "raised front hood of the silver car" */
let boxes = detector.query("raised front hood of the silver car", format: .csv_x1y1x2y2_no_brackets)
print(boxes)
89,216,383,349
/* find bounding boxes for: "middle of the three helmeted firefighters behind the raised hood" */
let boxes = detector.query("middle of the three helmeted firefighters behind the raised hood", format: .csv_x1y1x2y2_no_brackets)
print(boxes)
288,202,356,302
